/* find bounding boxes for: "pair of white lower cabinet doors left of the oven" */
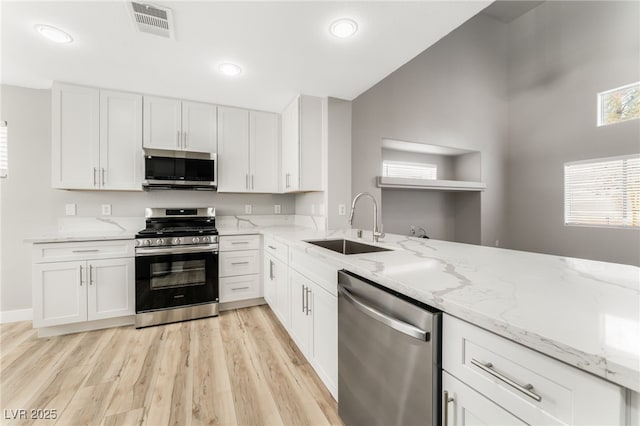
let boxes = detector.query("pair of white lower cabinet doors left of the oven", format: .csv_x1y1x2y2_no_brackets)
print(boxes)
33,251,135,328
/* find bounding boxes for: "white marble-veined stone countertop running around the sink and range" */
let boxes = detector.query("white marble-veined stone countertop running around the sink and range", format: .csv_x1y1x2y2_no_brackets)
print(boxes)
28,224,640,392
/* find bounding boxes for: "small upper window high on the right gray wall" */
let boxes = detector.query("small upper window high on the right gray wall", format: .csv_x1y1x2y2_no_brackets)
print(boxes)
598,82,640,126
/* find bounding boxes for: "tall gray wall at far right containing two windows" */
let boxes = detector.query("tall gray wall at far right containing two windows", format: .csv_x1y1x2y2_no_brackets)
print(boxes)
507,1,640,265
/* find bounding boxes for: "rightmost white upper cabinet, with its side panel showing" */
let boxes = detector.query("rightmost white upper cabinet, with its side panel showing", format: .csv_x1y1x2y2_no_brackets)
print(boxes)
282,95,324,192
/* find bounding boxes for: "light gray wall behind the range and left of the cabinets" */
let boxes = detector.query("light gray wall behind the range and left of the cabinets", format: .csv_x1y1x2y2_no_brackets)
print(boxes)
0,86,295,311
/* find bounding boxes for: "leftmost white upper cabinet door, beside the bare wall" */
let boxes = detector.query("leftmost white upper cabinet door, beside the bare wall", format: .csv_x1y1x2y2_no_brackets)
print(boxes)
52,83,100,189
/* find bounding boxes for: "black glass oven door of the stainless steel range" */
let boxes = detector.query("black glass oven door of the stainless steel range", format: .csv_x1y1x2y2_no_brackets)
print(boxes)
136,246,218,313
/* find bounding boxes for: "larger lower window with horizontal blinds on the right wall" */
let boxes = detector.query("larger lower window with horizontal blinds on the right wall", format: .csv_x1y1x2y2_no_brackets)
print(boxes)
564,155,640,228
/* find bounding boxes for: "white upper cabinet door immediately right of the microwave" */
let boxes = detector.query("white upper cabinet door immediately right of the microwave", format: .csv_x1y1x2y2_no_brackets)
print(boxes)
218,107,250,192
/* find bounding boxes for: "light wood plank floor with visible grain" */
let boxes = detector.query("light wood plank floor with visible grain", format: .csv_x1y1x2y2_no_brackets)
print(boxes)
0,305,342,426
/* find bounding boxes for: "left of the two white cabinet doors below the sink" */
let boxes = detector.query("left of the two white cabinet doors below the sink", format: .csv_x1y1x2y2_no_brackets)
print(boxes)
289,270,313,357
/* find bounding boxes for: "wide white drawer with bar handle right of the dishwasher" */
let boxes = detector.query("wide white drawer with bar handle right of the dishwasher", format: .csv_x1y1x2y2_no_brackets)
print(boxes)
442,315,624,425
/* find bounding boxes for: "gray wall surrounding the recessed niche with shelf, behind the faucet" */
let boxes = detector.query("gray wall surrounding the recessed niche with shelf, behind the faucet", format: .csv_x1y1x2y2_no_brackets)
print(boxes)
351,15,507,245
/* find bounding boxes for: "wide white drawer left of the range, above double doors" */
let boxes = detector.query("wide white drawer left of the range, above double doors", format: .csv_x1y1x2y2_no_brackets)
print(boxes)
33,240,134,263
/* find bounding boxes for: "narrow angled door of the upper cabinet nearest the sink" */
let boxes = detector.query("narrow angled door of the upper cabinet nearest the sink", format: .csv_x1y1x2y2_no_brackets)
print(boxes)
282,97,300,192
